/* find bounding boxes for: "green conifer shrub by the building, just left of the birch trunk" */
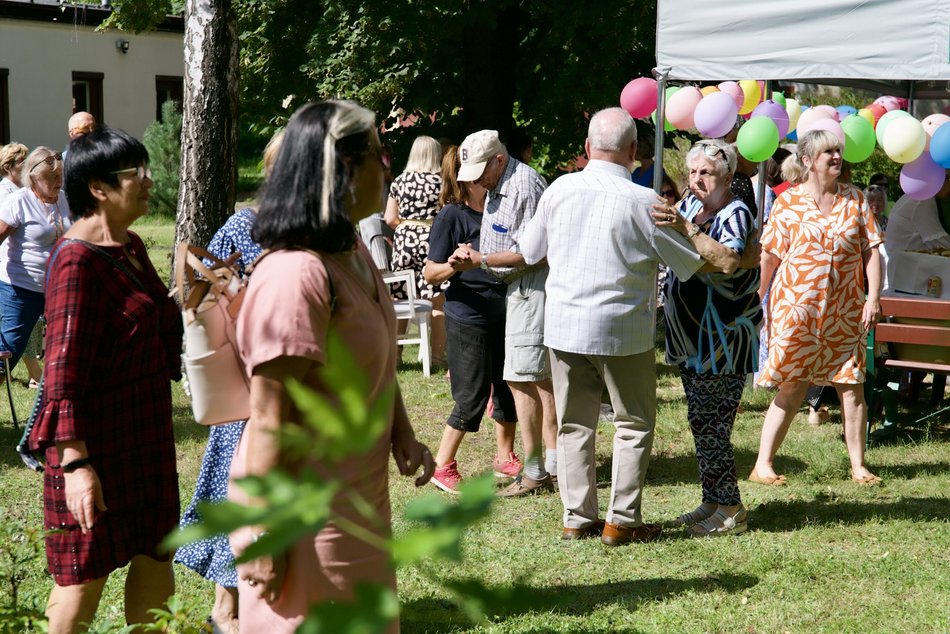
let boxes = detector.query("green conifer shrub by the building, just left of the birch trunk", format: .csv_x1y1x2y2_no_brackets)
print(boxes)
142,100,182,218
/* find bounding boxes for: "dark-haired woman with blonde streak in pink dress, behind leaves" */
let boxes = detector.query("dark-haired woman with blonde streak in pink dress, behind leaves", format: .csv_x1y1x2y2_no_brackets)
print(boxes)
229,101,434,634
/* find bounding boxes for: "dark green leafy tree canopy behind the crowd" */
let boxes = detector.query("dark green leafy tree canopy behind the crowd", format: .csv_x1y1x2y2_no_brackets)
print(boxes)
98,0,656,168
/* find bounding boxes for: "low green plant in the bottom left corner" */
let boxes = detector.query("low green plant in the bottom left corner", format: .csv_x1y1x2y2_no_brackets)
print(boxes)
0,508,47,634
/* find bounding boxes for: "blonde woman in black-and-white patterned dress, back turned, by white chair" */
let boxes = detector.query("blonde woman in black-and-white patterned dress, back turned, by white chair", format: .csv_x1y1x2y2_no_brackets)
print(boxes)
384,136,448,365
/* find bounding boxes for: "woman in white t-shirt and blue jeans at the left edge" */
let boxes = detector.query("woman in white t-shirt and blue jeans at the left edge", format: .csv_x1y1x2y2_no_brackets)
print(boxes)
0,146,72,367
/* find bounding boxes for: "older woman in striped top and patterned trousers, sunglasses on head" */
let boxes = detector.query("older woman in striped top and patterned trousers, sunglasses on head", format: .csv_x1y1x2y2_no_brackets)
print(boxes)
654,140,762,537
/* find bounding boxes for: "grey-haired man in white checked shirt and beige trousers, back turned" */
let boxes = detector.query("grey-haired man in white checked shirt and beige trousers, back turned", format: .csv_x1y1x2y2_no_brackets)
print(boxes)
521,108,703,545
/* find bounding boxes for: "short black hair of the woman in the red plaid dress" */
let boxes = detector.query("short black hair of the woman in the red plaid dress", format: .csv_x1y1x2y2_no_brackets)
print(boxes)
63,126,148,220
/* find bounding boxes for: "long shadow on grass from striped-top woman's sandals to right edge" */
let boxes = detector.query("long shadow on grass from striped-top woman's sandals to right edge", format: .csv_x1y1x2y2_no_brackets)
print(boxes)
749,494,947,532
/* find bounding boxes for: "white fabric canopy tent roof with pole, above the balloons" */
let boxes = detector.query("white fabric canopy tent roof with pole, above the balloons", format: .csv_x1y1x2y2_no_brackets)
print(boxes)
654,0,950,215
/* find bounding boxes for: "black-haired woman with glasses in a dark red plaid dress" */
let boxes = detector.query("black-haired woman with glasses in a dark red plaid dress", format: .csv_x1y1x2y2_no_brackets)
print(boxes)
30,128,181,634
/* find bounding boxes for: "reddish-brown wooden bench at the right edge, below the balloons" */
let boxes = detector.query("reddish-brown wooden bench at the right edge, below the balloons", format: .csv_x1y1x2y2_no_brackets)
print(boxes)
865,295,950,443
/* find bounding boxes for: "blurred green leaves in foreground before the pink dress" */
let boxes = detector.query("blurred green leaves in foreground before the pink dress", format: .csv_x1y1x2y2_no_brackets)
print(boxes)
165,336,495,634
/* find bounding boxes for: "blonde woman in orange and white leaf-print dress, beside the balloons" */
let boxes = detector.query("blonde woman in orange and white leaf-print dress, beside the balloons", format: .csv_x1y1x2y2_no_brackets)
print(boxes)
749,130,883,485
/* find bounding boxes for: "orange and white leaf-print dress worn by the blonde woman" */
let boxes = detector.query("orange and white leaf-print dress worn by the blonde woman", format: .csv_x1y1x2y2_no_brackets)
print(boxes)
758,180,883,387
